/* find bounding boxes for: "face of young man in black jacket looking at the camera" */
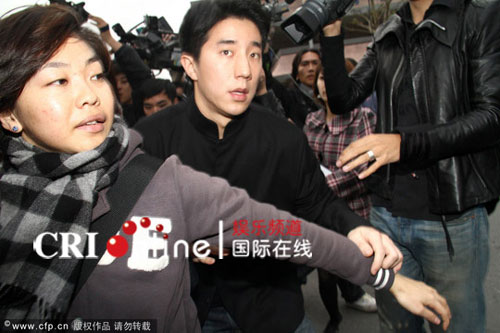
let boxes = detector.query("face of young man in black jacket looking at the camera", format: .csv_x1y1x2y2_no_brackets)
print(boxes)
183,18,262,127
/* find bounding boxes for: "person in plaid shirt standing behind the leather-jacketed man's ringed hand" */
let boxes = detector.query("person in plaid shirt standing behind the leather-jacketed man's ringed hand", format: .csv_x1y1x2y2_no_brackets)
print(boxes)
304,60,377,333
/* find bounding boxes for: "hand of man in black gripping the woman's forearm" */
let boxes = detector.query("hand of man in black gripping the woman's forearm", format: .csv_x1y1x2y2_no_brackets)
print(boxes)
347,226,403,275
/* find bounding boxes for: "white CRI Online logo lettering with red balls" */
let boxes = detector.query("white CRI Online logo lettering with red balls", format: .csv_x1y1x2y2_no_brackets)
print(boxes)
33,216,224,271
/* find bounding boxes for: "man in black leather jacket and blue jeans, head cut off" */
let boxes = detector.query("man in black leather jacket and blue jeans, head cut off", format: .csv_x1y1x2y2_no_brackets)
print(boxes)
321,0,500,332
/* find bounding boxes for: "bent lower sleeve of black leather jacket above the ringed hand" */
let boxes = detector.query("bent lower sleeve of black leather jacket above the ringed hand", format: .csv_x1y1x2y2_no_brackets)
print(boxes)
396,2,500,163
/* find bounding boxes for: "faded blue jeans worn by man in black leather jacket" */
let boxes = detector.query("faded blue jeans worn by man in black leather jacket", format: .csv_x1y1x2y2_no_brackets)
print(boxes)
370,207,489,333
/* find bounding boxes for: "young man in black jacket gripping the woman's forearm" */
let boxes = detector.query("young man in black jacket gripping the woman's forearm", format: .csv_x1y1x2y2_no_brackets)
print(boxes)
137,0,410,333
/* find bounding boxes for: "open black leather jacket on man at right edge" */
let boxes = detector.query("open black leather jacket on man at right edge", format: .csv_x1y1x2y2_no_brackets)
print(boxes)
321,0,500,214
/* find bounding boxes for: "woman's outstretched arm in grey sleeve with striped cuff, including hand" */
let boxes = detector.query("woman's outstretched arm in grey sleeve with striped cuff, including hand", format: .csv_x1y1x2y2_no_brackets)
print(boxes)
168,157,451,329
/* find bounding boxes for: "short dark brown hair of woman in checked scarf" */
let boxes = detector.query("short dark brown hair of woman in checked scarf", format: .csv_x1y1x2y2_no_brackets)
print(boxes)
0,5,110,112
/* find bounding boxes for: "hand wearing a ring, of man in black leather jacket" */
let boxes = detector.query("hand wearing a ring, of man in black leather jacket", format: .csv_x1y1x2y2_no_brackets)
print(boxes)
337,134,401,179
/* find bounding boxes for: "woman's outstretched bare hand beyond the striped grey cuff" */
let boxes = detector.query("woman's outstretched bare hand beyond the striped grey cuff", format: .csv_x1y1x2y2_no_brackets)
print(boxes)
390,274,451,331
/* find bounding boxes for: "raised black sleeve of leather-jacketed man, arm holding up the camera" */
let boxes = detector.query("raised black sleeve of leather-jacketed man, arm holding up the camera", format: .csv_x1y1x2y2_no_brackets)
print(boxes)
320,34,377,114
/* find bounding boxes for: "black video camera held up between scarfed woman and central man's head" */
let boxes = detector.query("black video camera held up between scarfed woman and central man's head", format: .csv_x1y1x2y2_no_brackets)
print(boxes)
112,16,181,69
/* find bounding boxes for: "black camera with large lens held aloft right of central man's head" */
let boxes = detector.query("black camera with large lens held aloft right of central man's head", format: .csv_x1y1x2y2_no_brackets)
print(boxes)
281,0,354,44
